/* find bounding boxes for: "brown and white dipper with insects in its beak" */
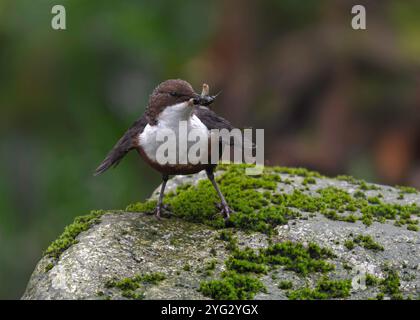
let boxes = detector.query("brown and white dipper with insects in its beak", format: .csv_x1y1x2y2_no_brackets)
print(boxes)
94,79,234,220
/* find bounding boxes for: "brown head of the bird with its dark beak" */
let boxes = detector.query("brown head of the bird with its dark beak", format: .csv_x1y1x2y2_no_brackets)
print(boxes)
146,79,214,124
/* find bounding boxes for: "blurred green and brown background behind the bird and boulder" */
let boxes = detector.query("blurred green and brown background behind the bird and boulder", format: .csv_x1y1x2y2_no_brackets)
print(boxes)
0,0,420,299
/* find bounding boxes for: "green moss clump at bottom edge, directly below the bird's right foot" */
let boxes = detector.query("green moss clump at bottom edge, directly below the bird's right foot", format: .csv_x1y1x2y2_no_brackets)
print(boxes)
199,271,265,300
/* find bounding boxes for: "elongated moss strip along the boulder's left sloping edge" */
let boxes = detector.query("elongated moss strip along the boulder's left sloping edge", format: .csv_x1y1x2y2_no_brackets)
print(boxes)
44,210,106,259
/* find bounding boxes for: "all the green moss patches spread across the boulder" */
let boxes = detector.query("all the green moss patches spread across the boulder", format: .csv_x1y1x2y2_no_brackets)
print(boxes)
41,165,420,298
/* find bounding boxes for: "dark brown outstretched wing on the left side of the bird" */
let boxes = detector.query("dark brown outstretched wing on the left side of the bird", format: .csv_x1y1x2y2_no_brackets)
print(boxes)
94,115,148,176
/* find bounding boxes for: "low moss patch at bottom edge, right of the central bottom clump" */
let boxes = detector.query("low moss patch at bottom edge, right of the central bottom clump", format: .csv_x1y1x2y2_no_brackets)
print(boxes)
288,278,351,300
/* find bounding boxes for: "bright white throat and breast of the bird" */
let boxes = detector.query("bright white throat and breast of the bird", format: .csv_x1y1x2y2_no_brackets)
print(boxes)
138,102,210,161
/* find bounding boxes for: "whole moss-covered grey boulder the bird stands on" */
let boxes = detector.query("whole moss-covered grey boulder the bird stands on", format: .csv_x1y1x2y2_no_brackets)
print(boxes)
22,165,420,299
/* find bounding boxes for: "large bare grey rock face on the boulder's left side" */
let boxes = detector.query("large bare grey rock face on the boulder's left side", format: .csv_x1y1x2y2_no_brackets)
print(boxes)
23,213,225,299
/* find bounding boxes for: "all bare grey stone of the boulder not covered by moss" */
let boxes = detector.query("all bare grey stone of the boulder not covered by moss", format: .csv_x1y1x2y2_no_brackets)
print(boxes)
22,173,420,299
